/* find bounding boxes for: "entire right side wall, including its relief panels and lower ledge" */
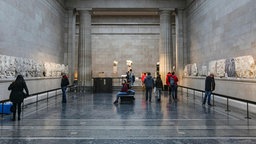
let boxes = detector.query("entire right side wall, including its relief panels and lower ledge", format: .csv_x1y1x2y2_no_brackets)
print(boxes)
182,0,256,101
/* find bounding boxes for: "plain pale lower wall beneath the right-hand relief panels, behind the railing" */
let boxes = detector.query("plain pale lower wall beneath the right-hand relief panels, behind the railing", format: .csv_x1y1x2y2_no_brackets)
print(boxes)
183,77,256,112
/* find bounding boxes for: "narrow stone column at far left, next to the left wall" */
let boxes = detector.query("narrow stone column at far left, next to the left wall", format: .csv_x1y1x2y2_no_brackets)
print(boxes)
67,9,77,83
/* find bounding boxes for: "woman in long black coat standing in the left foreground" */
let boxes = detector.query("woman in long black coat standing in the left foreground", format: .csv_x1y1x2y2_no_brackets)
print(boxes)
8,75,29,121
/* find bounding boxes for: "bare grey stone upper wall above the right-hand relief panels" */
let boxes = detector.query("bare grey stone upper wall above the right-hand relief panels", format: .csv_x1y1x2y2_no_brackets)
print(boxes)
187,0,256,72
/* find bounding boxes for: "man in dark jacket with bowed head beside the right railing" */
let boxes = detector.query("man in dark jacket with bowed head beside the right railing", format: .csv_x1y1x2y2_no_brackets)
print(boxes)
203,73,215,106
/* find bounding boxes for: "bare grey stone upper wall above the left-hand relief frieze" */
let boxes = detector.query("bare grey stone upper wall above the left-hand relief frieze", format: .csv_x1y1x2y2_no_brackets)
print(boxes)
0,0,66,66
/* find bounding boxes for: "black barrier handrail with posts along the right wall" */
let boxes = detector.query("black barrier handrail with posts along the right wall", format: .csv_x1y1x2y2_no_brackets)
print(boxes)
178,85,256,119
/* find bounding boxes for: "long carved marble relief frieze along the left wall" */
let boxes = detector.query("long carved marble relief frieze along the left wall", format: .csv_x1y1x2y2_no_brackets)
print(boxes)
0,55,68,79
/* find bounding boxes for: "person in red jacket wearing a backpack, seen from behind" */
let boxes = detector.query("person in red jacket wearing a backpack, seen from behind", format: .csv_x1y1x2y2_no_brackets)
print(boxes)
169,72,179,101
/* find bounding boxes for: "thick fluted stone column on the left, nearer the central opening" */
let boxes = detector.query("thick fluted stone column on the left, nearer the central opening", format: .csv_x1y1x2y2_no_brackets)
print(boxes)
78,10,92,88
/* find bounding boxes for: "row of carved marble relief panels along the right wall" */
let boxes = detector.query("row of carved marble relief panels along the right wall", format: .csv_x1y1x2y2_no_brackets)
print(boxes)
184,55,256,78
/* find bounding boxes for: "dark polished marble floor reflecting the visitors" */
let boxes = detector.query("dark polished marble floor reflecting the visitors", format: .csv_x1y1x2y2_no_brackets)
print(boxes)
0,90,256,144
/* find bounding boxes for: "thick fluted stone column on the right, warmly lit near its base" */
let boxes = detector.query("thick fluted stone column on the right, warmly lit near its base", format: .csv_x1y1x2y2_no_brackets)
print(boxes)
159,10,173,82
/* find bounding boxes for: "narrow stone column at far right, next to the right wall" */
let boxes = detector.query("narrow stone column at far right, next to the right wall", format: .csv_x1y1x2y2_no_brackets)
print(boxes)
175,9,184,84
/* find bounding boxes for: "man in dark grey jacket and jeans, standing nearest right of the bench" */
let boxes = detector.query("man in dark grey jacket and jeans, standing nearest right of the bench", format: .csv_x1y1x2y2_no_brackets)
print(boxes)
144,72,154,102
